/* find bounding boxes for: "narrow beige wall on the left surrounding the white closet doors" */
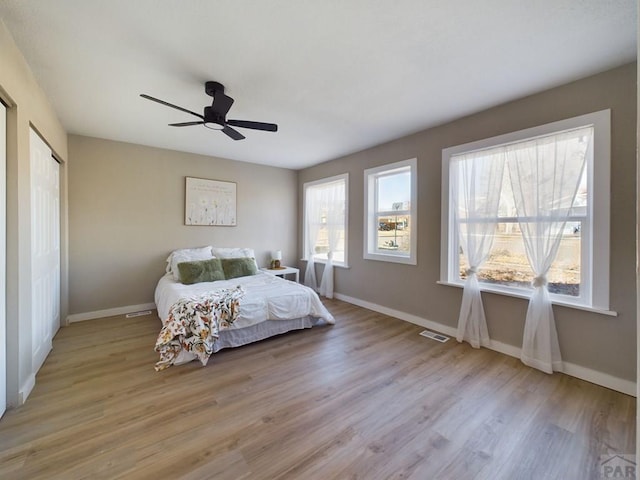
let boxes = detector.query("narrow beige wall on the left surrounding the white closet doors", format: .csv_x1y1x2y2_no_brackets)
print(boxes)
0,22,68,406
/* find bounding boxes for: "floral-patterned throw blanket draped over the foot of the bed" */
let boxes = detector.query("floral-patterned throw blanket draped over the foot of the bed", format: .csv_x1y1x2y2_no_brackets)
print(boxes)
155,286,245,371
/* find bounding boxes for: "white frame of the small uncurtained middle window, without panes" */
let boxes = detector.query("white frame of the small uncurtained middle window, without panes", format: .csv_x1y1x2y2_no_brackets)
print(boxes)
363,158,418,265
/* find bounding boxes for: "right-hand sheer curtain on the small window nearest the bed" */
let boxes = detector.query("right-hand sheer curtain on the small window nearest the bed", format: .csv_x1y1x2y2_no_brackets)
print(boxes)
319,181,345,298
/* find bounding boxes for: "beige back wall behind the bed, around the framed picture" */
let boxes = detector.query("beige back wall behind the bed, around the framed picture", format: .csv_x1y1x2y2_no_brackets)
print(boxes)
69,135,298,315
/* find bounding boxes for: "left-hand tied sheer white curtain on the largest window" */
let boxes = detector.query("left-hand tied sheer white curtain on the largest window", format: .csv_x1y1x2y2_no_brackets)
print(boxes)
451,148,504,348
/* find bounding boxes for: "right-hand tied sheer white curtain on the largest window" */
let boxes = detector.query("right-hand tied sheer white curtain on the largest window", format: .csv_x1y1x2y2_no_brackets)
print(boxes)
507,127,593,373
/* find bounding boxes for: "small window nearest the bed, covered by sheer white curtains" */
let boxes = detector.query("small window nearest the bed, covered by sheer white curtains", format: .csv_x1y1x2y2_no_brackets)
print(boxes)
303,173,349,267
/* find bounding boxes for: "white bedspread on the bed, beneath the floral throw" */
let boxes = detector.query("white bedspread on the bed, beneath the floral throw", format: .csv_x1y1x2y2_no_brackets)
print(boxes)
155,272,335,329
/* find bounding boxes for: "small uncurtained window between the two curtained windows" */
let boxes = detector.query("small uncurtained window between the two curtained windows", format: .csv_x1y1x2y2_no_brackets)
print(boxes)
364,158,417,265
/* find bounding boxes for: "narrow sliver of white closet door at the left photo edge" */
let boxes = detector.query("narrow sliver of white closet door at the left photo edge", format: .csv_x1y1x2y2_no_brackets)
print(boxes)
0,103,7,417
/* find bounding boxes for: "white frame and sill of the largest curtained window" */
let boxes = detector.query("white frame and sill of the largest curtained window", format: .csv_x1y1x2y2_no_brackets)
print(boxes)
439,109,615,315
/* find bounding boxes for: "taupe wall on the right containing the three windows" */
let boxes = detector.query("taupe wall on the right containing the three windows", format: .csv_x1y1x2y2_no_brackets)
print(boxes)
298,64,636,382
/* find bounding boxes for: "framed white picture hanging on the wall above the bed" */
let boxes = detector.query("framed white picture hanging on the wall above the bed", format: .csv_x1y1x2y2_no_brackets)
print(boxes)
184,177,237,227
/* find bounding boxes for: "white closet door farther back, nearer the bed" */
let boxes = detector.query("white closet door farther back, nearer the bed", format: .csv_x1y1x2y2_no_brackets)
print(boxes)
30,130,60,373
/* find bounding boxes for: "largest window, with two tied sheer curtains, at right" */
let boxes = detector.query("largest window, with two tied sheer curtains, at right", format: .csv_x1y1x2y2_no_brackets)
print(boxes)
441,110,610,310
